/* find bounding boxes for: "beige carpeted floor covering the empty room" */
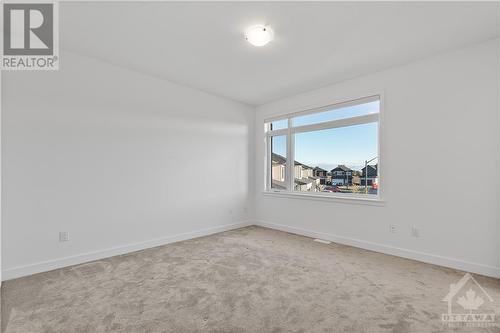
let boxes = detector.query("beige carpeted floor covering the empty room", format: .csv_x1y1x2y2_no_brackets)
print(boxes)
1,226,500,333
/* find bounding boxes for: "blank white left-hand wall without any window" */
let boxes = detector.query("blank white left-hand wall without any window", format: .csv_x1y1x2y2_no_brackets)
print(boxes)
2,52,254,279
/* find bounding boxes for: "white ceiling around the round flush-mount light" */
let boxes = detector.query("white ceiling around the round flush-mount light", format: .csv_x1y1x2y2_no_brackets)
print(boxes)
60,2,499,105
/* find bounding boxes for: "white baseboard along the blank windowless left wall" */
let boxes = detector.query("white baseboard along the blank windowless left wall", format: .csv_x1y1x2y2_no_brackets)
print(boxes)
2,221,254,281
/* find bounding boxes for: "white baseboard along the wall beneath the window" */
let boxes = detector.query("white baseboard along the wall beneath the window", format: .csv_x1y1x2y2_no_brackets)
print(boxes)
255,221,500,278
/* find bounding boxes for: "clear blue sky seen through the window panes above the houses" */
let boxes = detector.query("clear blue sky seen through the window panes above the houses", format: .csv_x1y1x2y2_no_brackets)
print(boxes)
273,101,379,170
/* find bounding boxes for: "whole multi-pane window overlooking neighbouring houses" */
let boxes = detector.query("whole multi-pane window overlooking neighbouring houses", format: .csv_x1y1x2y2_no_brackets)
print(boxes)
265,96,380,198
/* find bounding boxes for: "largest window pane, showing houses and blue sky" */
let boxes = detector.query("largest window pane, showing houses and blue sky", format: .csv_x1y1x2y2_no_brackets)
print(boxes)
294,122,378,195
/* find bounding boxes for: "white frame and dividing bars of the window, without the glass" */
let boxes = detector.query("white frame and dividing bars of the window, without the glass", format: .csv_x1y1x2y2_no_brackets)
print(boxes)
264,93,383,201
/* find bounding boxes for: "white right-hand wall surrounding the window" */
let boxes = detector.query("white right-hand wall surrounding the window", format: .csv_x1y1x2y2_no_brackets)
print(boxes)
255,40,500,277
